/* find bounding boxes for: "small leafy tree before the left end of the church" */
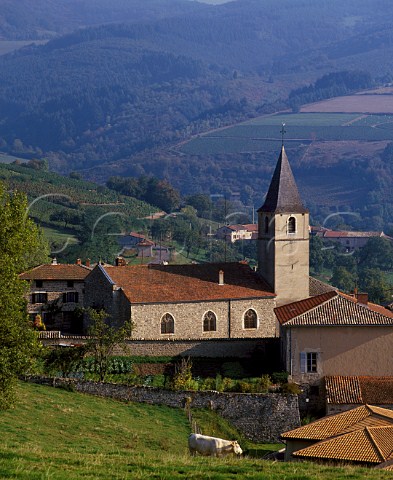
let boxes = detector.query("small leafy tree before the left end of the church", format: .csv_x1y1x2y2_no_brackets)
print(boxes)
87,308,132,382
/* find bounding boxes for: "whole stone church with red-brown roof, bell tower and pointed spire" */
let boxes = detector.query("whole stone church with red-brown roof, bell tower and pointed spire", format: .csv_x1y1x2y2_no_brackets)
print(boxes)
84,146,329,341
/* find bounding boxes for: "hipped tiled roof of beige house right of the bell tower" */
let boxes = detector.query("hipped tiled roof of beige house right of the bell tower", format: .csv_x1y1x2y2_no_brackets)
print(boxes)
274,291,393,327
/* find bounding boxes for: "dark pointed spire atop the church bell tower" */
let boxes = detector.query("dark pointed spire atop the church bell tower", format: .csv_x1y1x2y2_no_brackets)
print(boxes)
258,145,308,213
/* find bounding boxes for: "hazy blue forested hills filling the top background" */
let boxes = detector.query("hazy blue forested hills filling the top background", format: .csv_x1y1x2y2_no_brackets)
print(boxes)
0,0,393,180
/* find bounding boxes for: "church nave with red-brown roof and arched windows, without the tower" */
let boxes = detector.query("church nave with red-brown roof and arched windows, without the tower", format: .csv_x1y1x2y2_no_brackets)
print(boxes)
84,263,277,340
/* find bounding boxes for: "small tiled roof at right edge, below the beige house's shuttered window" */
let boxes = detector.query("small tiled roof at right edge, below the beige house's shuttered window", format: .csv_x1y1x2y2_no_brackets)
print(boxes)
325,375,393,405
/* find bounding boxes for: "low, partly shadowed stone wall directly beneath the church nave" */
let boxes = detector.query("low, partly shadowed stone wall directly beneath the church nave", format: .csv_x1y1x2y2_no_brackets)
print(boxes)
40,332,279,361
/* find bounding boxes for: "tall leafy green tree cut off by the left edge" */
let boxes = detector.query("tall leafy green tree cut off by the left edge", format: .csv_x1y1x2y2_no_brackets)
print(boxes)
0,184,41,409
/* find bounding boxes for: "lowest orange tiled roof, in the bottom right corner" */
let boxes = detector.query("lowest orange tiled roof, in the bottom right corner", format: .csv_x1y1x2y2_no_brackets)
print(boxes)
292,426,393,463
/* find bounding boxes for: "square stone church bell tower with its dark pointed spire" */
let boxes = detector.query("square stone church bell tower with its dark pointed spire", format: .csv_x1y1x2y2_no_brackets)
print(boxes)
258,145,310,305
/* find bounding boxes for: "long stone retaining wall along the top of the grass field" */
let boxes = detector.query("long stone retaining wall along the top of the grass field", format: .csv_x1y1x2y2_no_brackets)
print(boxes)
26,377,300,442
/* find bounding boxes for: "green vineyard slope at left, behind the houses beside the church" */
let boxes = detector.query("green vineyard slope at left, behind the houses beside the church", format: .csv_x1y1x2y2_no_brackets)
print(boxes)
0,162,158,263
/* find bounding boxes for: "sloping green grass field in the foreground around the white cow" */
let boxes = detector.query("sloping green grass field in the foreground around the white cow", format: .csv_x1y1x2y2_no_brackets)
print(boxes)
0,384,391,480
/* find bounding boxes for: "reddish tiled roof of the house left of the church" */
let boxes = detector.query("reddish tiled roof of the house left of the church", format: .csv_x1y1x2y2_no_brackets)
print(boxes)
20,263,91,280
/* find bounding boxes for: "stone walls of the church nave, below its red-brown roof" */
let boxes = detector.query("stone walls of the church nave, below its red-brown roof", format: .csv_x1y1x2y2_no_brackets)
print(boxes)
85,268,277,340
